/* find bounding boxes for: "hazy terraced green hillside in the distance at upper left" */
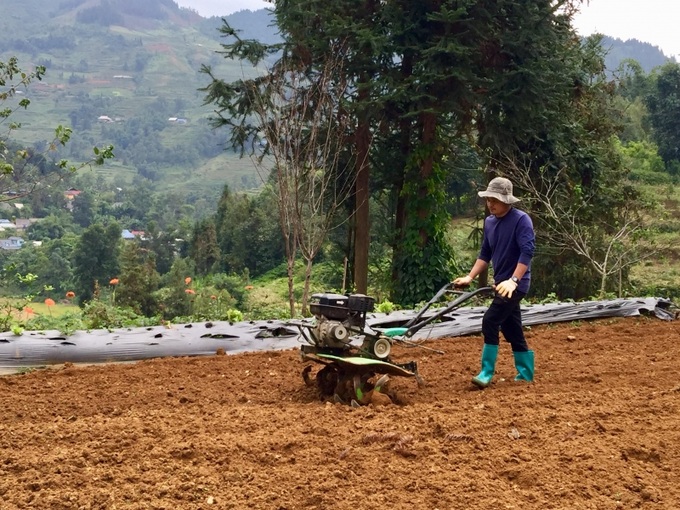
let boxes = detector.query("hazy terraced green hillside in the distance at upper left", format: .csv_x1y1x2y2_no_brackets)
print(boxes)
0,0,274,195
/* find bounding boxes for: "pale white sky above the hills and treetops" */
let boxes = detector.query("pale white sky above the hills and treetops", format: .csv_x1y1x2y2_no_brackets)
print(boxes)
175,0,680,60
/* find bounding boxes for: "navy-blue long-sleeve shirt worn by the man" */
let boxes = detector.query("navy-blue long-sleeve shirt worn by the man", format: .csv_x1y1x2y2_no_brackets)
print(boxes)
479,207,536,293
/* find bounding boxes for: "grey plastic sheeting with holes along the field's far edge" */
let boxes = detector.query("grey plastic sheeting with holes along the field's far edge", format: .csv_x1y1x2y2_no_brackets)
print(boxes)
0,298,677,372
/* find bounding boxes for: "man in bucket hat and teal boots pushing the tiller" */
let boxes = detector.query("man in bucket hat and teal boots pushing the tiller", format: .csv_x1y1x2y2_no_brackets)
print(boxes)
453,177,535,388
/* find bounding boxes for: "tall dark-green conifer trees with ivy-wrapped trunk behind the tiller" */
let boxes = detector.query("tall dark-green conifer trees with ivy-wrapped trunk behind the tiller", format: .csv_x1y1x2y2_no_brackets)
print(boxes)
204,1,614,303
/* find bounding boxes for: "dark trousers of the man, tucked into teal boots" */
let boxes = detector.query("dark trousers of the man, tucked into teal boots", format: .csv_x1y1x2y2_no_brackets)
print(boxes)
482,292,529,352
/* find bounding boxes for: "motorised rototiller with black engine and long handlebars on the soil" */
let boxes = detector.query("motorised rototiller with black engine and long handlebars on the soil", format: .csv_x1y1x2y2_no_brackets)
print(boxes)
291,284,493,405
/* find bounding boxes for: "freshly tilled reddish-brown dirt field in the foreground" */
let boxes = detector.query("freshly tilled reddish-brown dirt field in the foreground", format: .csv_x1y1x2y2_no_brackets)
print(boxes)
0,317,680,510
